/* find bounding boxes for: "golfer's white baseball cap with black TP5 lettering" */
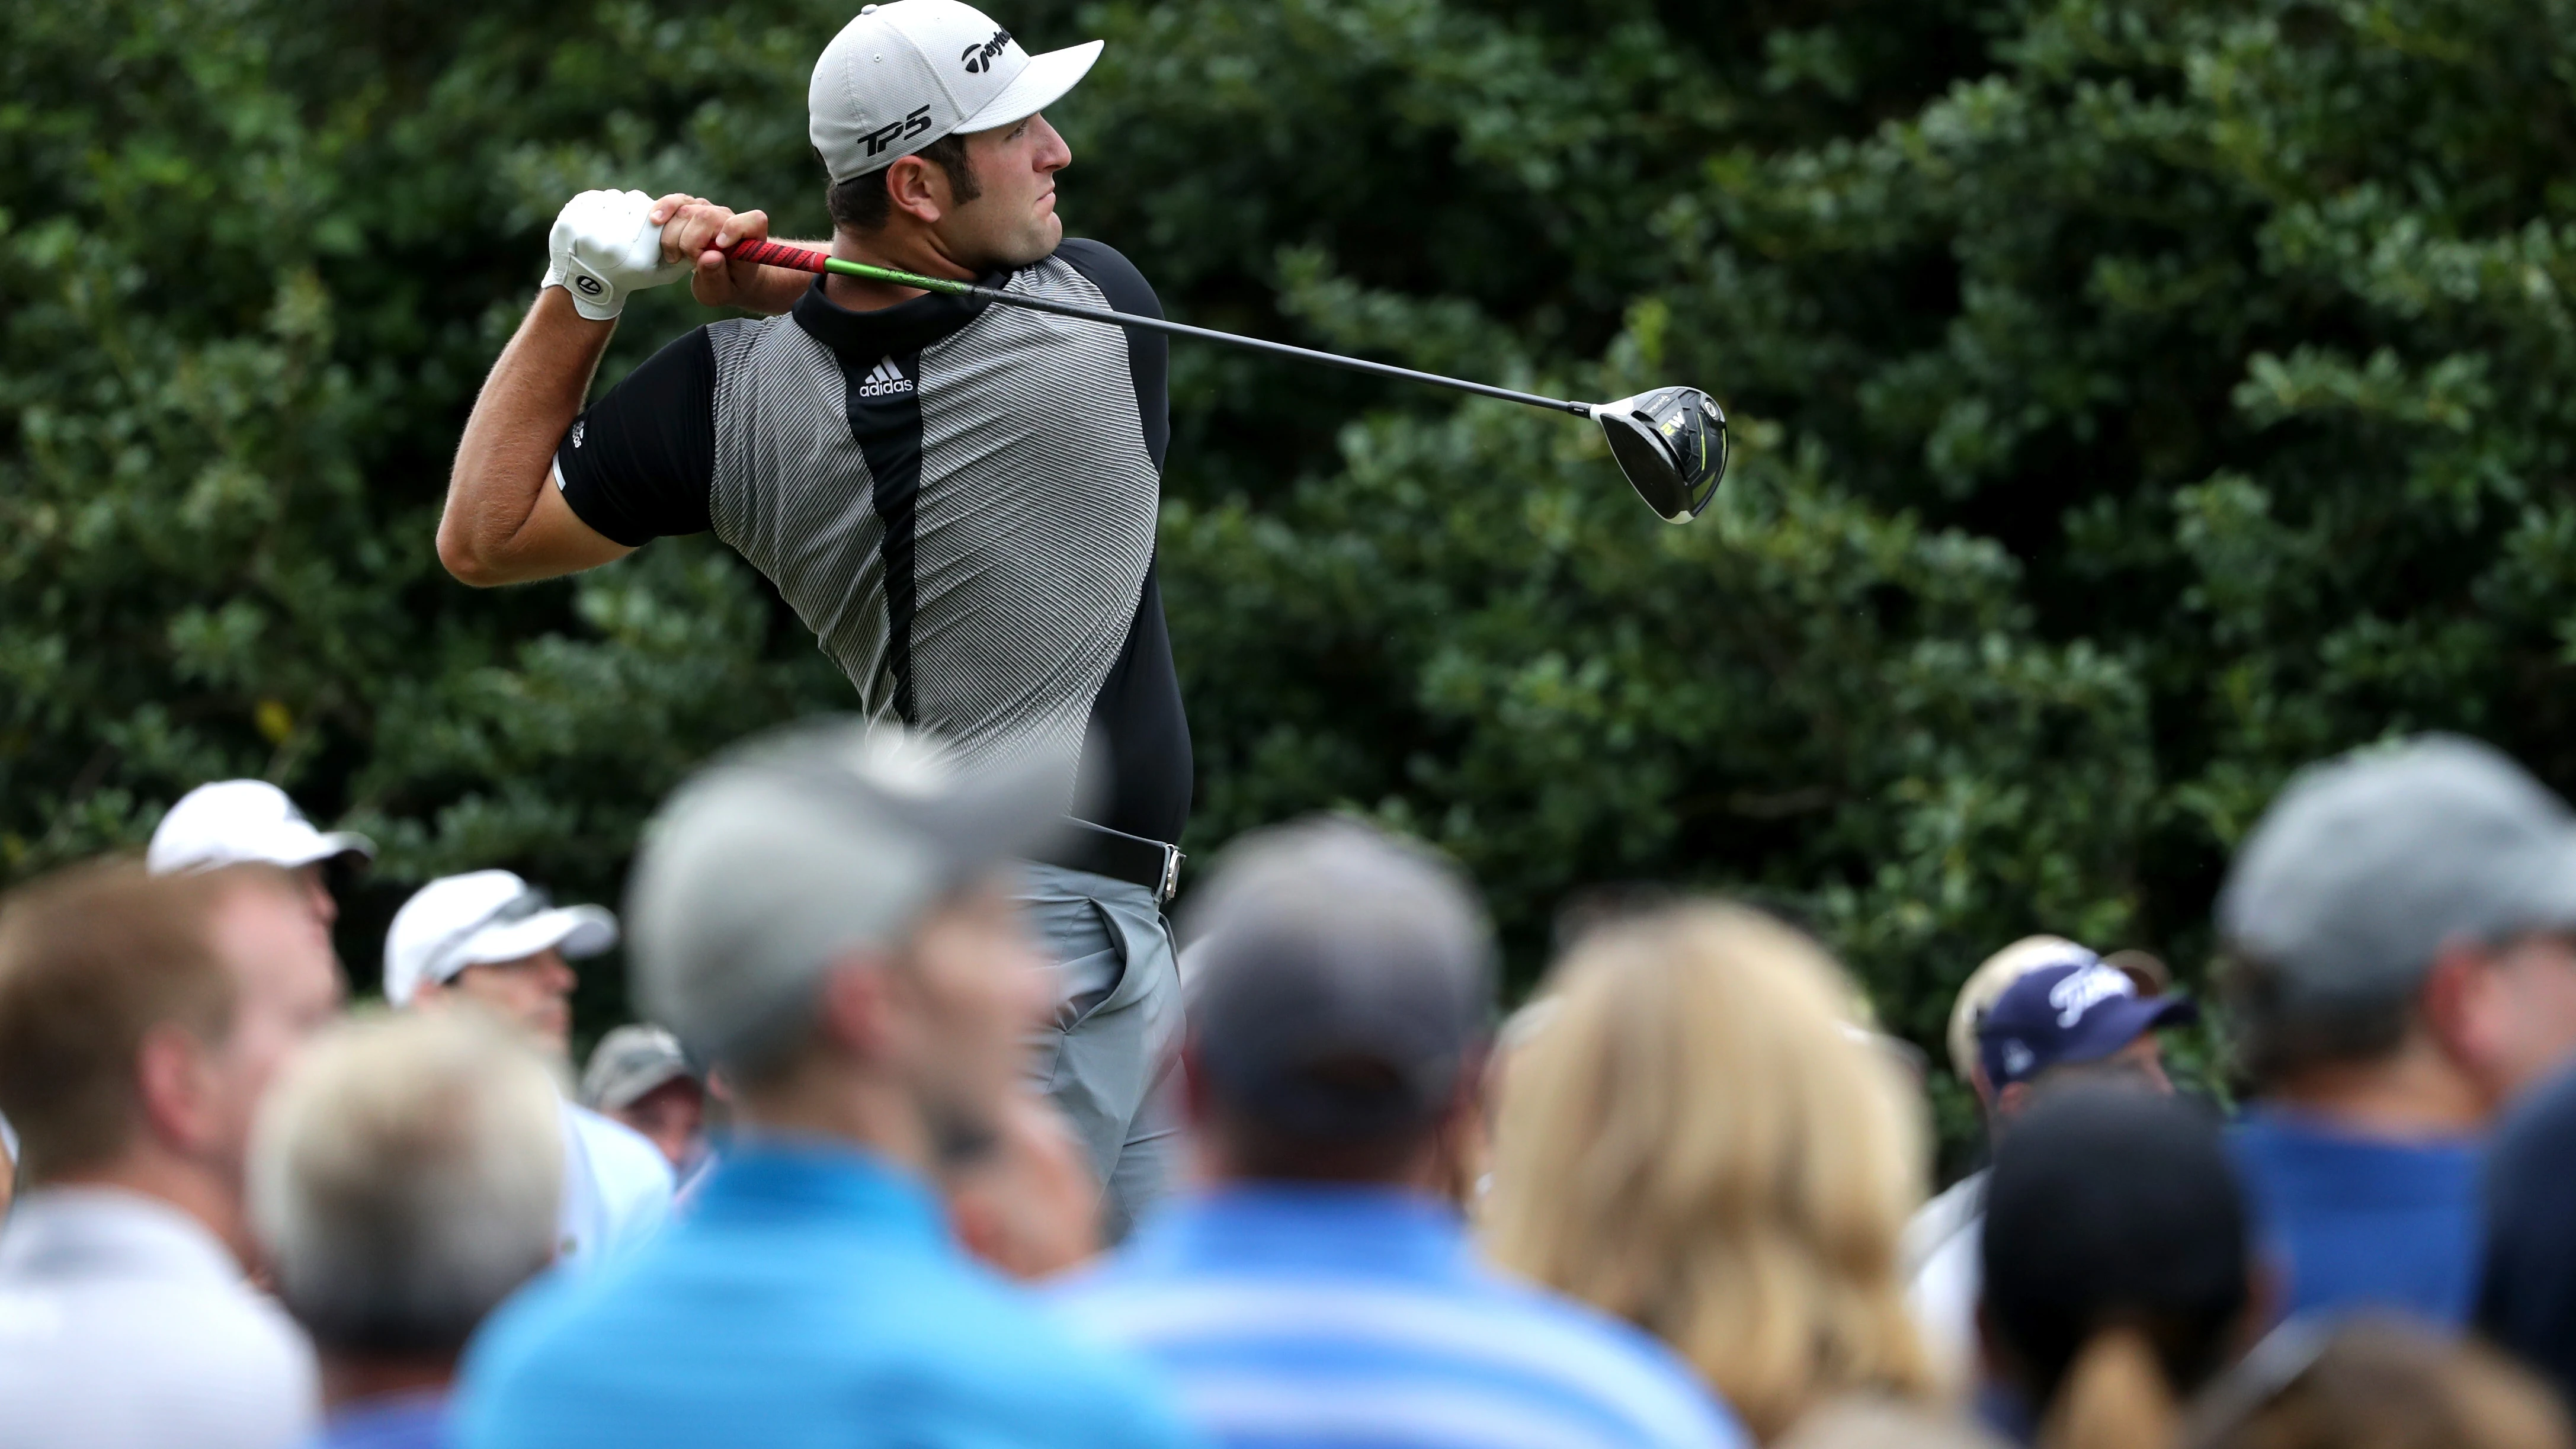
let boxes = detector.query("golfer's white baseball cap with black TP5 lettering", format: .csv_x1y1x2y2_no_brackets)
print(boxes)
806,0,1103,185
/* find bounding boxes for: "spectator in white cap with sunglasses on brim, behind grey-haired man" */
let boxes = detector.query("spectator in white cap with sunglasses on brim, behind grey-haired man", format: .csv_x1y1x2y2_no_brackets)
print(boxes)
384,870,678,1261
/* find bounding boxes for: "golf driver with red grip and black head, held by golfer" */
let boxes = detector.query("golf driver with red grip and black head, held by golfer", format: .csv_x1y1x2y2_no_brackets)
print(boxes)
726,242,1726,522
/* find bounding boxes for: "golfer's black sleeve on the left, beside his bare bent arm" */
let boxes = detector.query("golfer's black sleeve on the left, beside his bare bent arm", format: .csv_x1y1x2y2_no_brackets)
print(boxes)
554,327,716,548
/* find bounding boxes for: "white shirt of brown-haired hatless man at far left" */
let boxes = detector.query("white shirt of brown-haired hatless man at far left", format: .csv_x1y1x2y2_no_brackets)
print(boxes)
0,1187,319,1449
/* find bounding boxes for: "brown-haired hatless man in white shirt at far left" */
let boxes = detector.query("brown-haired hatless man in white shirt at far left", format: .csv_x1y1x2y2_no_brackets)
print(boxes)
0,862,340,1449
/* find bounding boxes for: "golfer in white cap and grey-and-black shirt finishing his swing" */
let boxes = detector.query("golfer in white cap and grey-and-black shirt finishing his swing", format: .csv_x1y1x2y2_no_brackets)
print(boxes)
438,0,1190,1233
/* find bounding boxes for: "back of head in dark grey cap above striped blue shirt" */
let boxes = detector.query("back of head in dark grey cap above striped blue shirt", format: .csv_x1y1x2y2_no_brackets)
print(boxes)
1187,819,1494,1140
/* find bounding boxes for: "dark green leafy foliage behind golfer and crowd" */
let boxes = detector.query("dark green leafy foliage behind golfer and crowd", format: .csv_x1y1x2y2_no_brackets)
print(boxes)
0,0,2576,1137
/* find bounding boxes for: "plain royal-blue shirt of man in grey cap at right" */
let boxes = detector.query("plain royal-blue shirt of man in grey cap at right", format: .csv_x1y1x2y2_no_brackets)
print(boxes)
2228,1110,2483,1328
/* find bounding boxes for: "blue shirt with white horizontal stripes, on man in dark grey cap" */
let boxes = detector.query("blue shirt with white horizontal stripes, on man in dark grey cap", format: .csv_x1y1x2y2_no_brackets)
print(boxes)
1059,1187,1747,1449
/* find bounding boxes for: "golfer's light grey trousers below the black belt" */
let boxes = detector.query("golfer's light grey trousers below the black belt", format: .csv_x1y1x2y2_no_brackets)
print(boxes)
1020,865,1183,1243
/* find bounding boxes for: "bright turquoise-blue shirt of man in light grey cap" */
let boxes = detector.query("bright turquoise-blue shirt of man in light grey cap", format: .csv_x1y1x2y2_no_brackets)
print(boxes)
453,1140,1193,1449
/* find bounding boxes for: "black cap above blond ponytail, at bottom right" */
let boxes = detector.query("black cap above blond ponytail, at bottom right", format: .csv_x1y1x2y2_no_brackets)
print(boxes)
1981,1083,2249,1397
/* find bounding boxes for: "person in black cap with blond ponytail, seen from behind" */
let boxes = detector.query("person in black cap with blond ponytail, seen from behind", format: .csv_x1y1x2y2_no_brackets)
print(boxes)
1978,1083,2262,1449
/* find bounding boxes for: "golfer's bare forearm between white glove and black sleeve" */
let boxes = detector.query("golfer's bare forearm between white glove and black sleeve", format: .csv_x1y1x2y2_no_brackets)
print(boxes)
438,288,616,587
